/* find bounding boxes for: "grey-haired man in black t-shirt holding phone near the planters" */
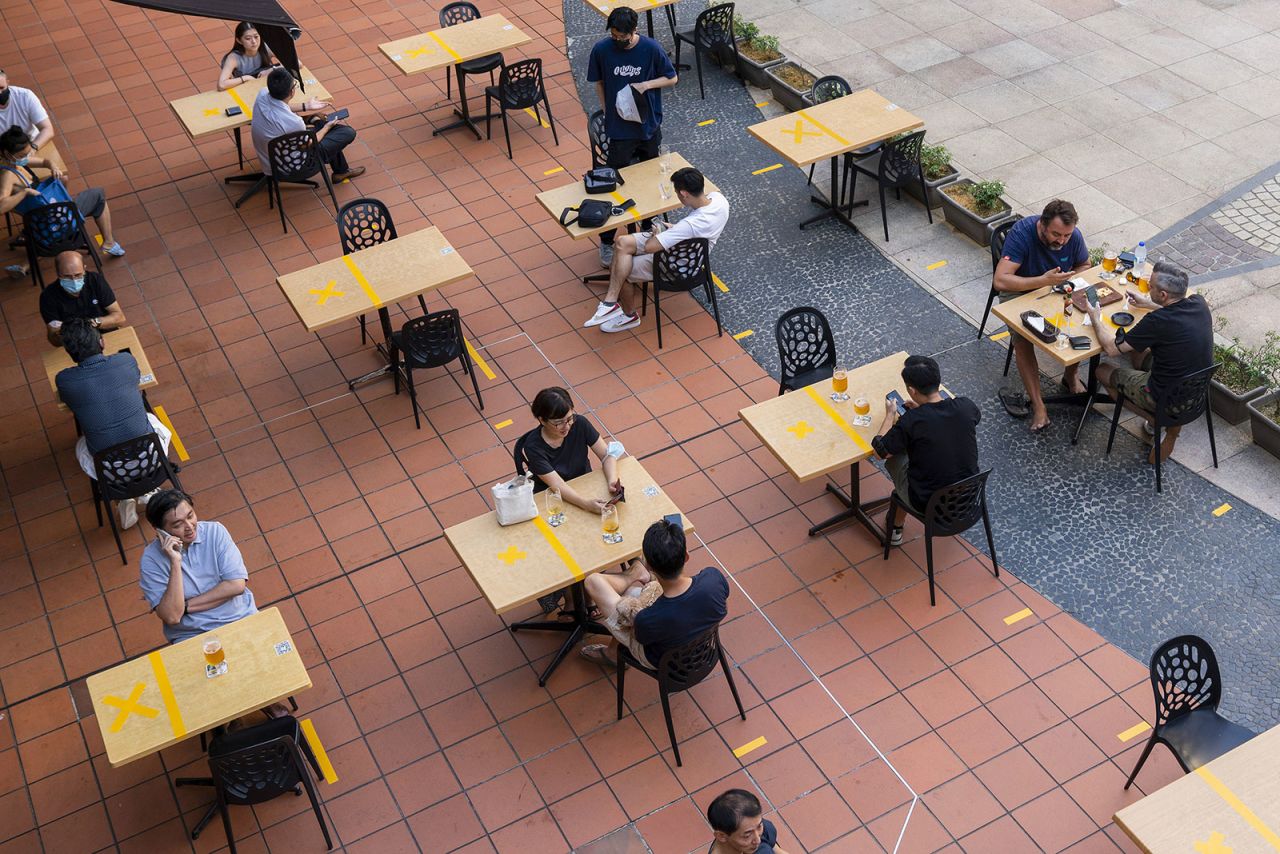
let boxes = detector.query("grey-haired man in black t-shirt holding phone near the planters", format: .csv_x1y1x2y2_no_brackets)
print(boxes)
1085,261,1213,462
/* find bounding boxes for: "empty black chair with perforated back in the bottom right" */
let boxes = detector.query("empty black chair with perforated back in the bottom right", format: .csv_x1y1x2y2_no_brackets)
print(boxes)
1124,635,1254,789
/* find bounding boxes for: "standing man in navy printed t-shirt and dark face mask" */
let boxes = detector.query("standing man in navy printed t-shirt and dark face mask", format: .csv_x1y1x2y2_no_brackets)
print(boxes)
586,6,677,268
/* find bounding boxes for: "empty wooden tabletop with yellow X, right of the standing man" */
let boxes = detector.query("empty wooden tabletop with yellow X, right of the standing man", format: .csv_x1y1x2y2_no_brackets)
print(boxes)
746,88,924,166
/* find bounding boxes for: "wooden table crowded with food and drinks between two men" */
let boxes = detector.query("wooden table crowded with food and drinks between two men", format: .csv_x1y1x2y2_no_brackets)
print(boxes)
991,266,1149,444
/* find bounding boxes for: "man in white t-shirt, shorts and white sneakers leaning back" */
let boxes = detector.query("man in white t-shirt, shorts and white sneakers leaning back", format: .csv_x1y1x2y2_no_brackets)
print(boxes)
582,166,728,332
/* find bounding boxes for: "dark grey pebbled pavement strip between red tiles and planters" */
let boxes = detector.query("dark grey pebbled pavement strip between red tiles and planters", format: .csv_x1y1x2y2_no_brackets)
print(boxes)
564,0,1280,731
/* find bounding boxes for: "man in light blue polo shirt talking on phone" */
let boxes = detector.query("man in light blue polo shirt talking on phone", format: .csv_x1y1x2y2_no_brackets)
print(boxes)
141,489,257,643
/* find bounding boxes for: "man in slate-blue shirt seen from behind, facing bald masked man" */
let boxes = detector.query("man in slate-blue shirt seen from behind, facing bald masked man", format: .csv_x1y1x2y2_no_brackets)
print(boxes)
50,318,169,529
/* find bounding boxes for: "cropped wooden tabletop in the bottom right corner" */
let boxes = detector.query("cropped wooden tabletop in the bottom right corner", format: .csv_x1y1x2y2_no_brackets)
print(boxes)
1115,726,1280,854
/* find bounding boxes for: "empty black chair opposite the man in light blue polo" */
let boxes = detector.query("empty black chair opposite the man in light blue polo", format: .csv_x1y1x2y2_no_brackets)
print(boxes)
174,714,333,854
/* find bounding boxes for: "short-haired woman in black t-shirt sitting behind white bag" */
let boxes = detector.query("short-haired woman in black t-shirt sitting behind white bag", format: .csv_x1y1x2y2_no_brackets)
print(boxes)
525,385,622,513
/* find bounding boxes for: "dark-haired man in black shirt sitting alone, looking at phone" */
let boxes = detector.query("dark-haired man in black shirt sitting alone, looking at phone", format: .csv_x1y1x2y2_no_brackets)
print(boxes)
872,356,982,545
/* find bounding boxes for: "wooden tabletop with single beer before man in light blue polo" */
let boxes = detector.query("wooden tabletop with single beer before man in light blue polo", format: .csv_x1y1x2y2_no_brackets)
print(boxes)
87,608,311,767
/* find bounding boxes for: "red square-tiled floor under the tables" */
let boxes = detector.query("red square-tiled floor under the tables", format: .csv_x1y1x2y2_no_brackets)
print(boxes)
0,0,1175,854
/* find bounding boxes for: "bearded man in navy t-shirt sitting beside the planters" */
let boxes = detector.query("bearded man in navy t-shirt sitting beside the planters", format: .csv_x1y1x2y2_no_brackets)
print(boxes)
992,198,1089,431
